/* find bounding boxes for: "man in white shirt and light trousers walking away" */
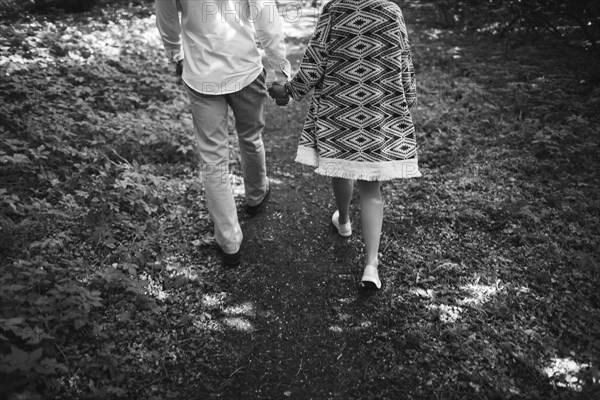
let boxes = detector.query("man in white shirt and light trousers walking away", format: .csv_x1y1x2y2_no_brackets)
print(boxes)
155,0,291,266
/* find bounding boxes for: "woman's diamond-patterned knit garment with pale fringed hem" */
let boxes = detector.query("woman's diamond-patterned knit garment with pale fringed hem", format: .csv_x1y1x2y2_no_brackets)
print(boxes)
286,0,421,181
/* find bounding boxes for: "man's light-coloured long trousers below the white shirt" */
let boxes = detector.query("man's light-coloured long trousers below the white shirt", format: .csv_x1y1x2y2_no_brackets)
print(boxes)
186,70,268,253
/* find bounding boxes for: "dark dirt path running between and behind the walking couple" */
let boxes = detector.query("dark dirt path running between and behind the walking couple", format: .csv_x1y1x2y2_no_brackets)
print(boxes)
216,96,384,398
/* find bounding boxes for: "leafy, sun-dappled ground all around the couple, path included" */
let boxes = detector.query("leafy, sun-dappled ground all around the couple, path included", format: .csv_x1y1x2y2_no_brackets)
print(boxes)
0,4,600,399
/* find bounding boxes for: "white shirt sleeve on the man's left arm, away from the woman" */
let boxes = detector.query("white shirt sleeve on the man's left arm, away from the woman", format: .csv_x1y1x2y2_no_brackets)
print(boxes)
154,0,184,62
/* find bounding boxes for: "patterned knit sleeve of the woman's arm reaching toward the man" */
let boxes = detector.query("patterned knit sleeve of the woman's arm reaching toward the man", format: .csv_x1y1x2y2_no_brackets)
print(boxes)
285,3,331,100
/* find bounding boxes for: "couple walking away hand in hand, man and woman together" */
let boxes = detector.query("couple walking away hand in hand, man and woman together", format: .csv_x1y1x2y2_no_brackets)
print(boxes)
155,0,420,289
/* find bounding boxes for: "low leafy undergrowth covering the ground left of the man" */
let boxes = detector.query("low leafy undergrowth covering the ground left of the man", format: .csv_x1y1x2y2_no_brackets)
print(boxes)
0,7,206,398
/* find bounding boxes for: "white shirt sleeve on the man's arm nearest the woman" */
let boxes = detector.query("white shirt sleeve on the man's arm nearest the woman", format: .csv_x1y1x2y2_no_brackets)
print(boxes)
248,0,291,82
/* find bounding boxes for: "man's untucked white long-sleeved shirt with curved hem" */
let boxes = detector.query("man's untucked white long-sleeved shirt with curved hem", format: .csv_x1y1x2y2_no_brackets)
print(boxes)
155,0,291,94
